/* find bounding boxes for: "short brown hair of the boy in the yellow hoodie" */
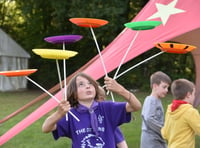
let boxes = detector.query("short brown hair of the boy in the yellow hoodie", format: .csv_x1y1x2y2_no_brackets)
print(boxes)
171,79,195,100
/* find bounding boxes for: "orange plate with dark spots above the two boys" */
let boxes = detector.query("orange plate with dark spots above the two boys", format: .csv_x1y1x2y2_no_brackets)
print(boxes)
155,43,196,54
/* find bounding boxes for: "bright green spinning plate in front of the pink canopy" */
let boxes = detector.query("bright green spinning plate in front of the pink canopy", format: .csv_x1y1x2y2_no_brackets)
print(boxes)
124,21,161,30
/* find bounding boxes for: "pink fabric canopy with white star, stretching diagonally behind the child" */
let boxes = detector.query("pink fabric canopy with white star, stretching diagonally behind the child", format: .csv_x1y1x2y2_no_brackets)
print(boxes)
0,0,200,145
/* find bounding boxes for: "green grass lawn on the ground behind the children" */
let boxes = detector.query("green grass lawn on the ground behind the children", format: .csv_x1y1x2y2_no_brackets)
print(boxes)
0,90,200,148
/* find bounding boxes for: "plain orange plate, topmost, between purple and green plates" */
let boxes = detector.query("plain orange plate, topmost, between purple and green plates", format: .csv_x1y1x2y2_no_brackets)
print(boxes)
69,18,108,28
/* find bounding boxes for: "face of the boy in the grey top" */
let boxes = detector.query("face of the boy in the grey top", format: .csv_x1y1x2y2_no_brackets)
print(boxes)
153,82,169,98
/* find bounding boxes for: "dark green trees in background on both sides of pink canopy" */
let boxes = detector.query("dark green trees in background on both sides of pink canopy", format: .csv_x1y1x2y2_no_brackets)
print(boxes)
0,0,195,90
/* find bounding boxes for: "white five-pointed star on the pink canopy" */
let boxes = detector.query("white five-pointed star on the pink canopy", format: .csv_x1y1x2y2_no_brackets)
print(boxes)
147,0,185,25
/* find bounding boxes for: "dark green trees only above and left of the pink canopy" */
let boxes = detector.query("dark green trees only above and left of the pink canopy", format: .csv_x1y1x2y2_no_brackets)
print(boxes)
0,0,147,87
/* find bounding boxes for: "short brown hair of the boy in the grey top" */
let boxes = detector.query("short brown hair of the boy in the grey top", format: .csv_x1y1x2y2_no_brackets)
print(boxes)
150,71,171,88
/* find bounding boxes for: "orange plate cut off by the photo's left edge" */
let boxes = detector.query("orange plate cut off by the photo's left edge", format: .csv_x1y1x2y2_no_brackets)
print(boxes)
0,69,37,77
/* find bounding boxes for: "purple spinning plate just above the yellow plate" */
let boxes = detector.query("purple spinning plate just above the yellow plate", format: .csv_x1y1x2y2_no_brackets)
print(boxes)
44,35,82,44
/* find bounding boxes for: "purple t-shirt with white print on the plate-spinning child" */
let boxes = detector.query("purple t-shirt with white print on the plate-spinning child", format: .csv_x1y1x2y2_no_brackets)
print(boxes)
53,101,131,148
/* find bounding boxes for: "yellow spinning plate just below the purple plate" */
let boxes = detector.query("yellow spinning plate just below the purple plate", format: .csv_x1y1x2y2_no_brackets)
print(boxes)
32,49,78,60
